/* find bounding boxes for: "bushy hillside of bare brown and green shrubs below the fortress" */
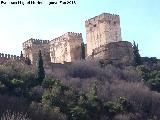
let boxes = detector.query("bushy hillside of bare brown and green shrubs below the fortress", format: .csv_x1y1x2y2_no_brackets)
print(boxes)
0,47,160,120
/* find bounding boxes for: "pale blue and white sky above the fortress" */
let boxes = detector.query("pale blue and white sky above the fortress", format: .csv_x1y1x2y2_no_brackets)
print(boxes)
0,0,160,58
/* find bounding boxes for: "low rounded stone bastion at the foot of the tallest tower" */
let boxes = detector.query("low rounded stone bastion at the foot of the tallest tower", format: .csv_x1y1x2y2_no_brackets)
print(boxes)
92,41,133,64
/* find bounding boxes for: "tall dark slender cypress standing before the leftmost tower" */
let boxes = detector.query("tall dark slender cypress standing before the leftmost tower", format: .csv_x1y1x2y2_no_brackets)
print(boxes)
37,50,45,84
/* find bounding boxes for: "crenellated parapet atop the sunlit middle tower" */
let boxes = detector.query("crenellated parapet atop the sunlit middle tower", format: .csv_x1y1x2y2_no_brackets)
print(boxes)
50,32,82,44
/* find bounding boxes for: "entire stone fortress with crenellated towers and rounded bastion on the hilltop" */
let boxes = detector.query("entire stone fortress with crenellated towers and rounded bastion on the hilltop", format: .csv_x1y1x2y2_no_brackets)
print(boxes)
0,13,133,65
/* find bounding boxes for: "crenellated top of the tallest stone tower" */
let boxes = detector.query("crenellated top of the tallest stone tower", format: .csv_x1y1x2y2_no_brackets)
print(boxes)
85,13,120,27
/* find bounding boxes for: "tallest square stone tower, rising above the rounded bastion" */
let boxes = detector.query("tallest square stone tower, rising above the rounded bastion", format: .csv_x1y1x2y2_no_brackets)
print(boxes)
85,13,122,56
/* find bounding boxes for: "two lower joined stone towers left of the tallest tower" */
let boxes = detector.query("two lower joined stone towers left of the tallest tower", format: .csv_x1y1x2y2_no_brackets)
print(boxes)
23,32,82,65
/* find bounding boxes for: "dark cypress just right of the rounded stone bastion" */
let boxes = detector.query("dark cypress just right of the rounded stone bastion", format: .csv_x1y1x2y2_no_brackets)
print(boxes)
133,41,141,66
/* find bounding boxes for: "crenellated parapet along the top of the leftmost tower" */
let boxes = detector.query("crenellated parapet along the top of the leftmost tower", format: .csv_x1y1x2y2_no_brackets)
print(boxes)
23,38,50,47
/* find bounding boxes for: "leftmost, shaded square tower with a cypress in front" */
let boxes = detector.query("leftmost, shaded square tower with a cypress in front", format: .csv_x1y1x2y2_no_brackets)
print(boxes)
23,38,50,65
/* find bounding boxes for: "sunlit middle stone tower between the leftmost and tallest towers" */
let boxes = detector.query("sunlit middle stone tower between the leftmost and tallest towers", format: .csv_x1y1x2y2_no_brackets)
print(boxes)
50,32,82,63
